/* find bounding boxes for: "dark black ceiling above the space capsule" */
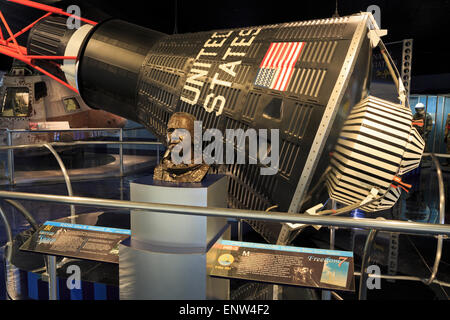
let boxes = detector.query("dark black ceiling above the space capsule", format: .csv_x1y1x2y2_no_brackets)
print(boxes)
0,0,450,76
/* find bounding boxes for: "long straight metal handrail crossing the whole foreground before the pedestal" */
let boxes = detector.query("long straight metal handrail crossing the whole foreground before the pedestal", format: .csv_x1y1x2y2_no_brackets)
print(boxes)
0,191,450,236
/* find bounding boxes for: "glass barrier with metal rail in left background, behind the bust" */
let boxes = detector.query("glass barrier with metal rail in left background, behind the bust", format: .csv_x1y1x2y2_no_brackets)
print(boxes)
0,126,163,185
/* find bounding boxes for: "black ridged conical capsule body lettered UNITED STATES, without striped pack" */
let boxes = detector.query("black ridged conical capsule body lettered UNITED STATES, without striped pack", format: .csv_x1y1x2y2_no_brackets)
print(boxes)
29,13,373,242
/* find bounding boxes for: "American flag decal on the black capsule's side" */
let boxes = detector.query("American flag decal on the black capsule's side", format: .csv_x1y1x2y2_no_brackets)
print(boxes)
254,42,305,91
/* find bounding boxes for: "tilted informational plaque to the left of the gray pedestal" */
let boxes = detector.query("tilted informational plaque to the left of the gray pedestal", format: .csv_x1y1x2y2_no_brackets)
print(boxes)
20,221,131,263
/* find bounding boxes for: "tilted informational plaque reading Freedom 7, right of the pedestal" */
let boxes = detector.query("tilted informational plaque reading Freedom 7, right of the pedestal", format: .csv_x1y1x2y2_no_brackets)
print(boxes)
207,240,355,291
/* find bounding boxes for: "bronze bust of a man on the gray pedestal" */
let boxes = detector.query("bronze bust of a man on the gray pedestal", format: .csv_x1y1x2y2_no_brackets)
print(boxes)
153,112,209,182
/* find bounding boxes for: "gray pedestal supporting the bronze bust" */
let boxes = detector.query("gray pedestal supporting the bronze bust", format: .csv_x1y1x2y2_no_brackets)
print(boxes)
119,175,229,300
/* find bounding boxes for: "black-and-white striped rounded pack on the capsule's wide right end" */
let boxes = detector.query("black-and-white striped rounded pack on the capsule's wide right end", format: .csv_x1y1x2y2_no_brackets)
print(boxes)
326,96,425,212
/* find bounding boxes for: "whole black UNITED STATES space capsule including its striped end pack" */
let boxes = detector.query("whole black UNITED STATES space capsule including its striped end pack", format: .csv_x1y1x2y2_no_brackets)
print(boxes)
0,0,424,242
